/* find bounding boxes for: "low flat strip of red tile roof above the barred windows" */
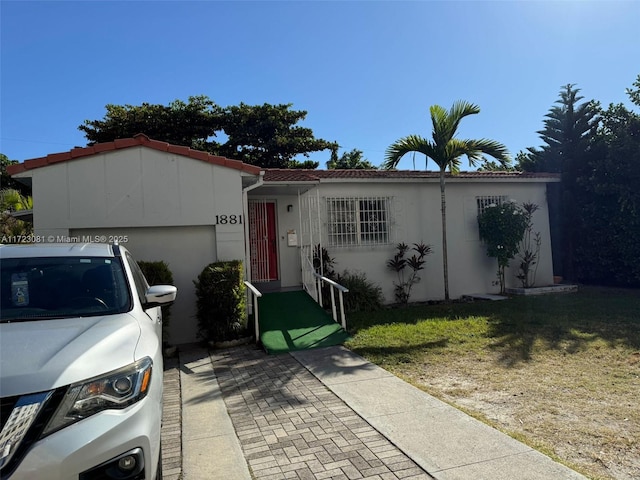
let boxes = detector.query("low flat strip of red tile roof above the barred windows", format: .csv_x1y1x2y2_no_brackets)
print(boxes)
264,168,560,183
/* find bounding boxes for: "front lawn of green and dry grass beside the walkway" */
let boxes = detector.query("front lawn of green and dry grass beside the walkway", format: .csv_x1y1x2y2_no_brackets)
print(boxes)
347,288,640,479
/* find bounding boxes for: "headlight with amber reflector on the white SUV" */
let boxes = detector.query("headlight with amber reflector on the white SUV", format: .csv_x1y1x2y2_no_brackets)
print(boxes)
42,357,153,436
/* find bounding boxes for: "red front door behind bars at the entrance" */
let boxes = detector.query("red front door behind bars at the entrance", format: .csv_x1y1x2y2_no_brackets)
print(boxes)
249,201,278,282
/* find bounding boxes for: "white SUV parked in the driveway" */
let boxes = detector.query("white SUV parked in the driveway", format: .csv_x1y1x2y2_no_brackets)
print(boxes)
0,244,176,480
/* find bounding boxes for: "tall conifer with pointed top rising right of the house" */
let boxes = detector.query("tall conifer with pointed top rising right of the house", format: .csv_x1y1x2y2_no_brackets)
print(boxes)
518,84,600,280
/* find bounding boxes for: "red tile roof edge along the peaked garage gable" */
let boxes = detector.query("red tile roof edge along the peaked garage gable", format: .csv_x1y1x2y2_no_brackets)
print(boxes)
7,133,262,175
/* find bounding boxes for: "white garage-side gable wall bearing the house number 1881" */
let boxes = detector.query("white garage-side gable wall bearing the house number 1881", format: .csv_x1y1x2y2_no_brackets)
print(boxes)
29,147,245,343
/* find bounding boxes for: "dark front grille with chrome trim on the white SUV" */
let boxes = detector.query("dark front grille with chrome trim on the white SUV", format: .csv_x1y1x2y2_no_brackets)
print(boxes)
0,389,65,478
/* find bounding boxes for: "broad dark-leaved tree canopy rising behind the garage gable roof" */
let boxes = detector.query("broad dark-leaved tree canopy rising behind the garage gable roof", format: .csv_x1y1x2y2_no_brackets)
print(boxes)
78,95,337,168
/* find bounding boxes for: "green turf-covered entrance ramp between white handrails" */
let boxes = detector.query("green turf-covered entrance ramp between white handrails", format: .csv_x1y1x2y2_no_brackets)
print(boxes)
259,291,349,353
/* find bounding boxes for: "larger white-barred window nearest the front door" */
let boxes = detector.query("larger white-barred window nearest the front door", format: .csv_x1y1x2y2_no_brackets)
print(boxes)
326,197,391,247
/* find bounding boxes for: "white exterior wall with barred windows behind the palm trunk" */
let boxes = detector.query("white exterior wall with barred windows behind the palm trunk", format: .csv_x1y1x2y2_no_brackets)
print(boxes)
290,179,553,303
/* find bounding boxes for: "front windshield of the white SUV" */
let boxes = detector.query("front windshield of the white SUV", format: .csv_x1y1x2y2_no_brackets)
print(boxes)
0,257,131,322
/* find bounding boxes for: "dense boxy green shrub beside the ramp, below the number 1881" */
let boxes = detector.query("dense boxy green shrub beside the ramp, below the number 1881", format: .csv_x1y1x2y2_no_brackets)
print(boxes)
193,260,247,342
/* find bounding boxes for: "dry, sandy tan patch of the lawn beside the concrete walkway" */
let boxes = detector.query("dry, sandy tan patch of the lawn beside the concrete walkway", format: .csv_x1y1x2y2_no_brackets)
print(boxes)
392,351,640,480
